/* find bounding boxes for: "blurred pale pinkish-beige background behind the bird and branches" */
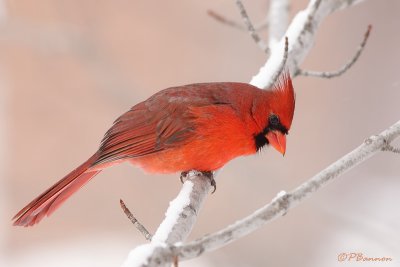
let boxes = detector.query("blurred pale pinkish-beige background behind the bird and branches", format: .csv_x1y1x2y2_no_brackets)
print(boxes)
0,0,400,267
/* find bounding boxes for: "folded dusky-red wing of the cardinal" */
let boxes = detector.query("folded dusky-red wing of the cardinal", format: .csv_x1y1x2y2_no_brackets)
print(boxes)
93,84,233,168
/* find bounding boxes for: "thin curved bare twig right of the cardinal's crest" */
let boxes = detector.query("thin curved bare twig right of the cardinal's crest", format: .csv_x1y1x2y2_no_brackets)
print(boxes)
295,25,372,79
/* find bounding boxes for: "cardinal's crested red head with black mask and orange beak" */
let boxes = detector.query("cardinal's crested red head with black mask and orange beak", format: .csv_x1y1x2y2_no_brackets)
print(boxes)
252,73,295,155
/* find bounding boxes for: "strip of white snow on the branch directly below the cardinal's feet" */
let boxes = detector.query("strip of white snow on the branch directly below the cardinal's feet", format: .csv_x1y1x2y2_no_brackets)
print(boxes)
152,181,193,242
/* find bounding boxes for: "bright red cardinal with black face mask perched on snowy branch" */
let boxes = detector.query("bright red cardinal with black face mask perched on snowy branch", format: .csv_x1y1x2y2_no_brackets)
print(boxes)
13,74,295,226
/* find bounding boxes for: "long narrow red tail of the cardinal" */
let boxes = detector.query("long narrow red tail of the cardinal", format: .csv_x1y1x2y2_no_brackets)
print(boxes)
13,153,101,227
